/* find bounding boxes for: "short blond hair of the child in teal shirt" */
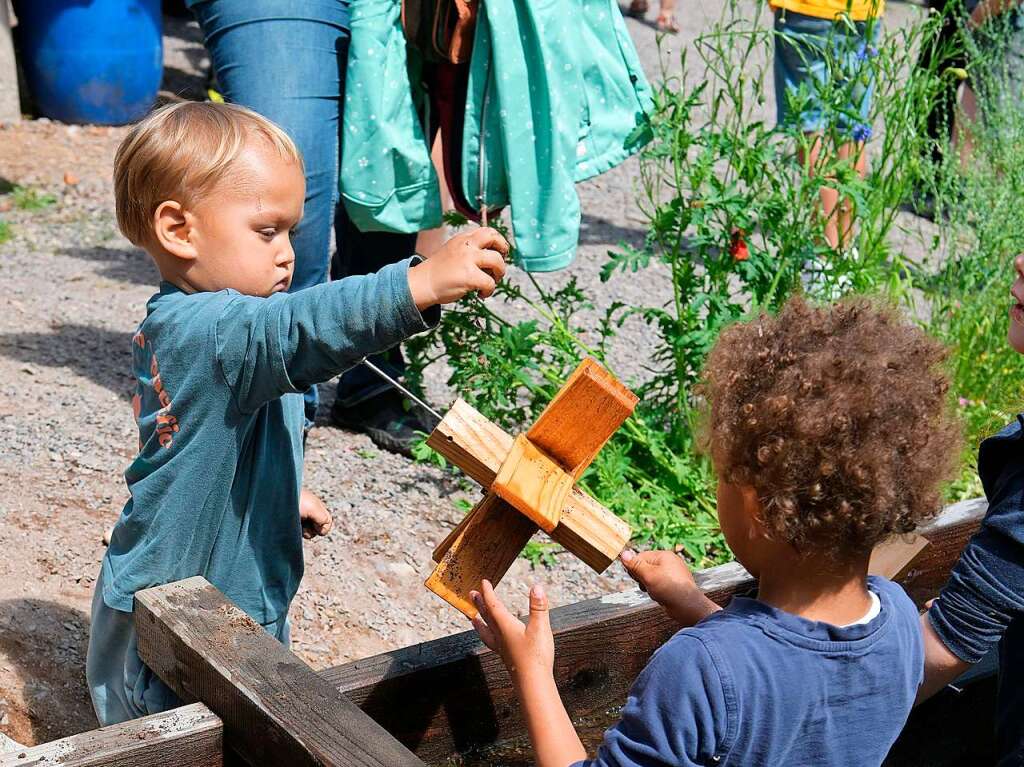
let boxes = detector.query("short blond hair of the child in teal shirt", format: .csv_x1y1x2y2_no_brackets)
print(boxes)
114,101,302,247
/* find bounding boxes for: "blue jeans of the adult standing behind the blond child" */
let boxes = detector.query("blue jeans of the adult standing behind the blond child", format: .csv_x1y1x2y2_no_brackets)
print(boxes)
188,0,416,422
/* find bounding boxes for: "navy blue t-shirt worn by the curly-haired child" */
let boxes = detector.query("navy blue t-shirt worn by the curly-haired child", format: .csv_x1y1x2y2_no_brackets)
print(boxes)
574,577,925,767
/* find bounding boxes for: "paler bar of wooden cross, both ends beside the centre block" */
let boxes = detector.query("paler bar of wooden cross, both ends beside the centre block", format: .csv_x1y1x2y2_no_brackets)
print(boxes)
427,399,630,572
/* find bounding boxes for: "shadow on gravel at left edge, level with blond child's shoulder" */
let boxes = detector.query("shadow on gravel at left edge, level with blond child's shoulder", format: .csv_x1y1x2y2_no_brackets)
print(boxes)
0,325,134,399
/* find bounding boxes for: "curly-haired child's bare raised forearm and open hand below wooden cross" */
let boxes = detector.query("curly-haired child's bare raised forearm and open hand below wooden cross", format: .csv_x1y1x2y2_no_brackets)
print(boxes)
470,581,587,767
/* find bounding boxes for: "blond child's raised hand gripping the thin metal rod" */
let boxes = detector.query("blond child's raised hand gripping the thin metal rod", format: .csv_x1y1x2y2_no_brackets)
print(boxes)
409,227,509,311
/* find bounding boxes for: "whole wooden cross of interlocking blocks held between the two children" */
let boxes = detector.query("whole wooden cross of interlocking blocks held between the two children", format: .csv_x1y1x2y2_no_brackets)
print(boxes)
426,359,637,617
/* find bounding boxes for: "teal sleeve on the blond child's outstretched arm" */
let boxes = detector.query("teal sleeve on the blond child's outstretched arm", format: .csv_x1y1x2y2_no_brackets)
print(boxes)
216,259,440,413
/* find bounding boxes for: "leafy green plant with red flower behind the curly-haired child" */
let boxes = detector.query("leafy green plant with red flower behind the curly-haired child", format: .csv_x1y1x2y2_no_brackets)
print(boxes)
412,2,1007,566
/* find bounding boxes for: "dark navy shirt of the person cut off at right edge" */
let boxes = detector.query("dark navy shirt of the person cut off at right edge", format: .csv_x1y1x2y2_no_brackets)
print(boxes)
928,414,1024,765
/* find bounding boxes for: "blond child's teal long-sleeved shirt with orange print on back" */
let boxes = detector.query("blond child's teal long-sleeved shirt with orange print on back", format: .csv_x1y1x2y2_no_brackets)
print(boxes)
102,260,437,625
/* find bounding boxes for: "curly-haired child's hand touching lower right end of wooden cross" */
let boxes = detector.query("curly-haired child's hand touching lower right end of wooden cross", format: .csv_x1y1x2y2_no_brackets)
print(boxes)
618,549,721,626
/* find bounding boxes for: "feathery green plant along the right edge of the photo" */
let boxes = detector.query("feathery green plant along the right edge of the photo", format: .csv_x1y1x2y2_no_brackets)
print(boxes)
924,8,1024,487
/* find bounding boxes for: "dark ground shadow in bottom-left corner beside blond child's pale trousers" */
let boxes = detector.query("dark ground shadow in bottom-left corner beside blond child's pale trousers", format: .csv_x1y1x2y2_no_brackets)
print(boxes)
0,599,97,743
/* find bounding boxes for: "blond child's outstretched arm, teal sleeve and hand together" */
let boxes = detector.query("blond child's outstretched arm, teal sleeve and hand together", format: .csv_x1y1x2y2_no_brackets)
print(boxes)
216,228,508,412
